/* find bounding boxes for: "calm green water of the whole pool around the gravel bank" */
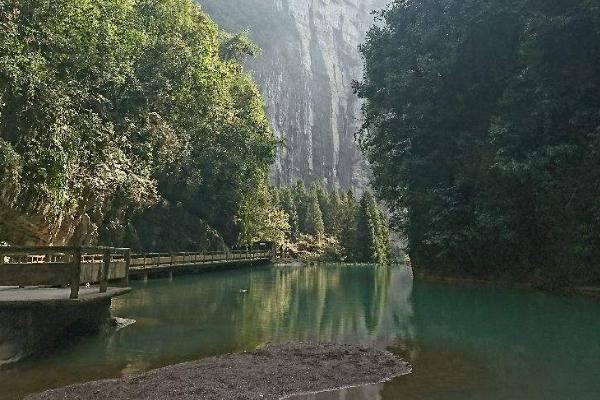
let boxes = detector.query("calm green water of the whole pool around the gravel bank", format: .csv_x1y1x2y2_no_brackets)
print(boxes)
0,266,600,400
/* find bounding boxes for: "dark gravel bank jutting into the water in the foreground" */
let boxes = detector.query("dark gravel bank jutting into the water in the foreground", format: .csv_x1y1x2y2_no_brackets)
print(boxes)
25,343,410,400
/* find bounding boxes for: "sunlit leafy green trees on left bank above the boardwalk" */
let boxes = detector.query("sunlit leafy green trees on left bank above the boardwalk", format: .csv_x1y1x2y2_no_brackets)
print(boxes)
0,0,276,251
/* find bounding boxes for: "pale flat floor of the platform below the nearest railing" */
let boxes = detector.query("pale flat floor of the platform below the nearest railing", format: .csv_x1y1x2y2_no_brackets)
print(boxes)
0,286,131,307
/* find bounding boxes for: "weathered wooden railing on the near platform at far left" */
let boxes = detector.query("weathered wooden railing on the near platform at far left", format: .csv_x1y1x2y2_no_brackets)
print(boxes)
0,247,131,299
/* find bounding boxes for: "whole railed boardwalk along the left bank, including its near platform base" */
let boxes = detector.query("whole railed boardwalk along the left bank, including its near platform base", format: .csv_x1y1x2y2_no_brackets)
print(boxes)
0,247,272,365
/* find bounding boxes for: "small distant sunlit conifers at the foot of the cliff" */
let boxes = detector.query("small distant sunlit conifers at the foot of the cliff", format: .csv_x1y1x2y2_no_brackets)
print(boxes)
274,181,392,265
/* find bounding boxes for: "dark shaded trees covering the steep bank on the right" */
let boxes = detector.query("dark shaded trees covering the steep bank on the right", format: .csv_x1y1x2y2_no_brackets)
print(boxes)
355,0,600,286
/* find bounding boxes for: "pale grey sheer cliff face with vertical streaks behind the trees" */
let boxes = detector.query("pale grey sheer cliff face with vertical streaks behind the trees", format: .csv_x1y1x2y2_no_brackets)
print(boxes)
198,0,387,188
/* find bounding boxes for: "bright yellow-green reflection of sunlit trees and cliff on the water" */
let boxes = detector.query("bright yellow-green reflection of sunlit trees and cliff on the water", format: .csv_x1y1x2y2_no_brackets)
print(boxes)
232,266,415,346
